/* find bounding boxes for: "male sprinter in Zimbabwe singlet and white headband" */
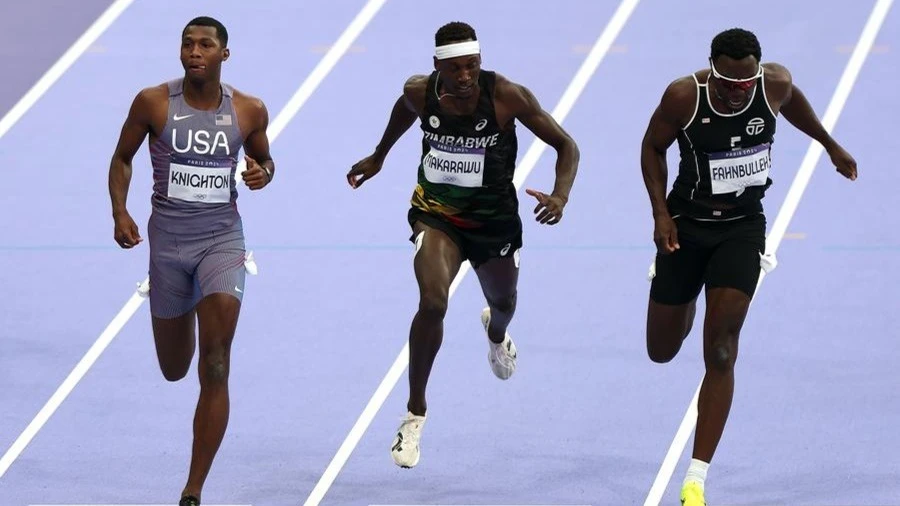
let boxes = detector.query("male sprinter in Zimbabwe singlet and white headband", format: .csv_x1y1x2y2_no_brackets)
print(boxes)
347,22,579,467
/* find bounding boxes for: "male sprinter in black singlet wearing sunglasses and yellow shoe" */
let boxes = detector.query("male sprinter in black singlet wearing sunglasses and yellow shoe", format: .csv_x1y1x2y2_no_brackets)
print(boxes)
641,29,856,506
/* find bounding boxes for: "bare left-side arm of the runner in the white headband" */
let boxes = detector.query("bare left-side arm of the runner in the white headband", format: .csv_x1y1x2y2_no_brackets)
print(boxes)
347,75,428,188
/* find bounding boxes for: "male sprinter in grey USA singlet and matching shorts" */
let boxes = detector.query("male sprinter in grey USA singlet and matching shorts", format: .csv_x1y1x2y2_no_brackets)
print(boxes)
109,17,275,506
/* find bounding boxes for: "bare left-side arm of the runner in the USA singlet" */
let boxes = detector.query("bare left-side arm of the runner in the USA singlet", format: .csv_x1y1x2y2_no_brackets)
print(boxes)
109,85,168,248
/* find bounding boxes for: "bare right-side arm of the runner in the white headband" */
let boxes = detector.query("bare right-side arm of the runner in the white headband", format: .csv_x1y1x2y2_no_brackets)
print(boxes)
494,75,580,225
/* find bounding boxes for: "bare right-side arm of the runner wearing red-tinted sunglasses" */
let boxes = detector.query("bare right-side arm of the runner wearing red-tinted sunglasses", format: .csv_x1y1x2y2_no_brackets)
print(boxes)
763,63,857,181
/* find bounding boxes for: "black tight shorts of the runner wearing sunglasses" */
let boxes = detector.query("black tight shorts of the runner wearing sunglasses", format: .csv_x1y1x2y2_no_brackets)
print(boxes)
650,213,766,305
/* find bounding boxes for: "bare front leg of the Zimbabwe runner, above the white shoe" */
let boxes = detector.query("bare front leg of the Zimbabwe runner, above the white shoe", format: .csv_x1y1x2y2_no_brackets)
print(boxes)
407,221,462,416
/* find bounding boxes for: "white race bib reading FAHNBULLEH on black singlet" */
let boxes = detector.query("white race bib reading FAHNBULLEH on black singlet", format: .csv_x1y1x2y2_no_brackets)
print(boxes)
709,143,772,195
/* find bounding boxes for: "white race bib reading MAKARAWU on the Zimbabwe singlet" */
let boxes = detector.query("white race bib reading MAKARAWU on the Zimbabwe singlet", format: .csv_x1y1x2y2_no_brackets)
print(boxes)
422,142,485,188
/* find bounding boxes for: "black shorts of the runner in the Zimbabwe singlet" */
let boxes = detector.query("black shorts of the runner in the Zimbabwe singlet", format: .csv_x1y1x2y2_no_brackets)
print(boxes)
407,207,522,267
